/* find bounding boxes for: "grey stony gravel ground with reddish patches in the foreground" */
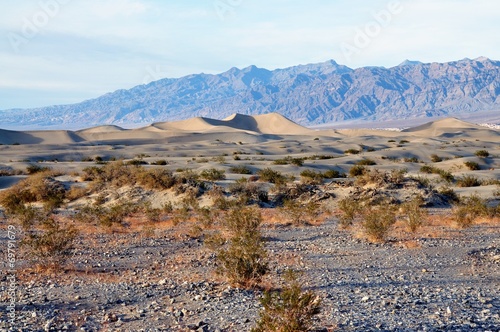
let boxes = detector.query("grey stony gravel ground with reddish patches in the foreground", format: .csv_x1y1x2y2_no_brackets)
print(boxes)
0,210,500,331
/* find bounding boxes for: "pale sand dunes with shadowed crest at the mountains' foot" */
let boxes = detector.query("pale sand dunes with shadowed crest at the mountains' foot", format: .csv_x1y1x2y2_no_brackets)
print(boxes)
0,113,500,145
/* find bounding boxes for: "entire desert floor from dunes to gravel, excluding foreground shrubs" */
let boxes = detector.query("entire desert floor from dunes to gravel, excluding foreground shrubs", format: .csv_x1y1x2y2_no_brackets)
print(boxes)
0,114,500,331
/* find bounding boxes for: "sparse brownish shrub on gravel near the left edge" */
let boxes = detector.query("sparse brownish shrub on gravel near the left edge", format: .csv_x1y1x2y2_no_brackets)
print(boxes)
21,217,78,266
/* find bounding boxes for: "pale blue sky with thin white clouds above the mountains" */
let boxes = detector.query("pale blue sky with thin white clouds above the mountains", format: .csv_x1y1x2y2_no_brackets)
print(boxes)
0,0,500,109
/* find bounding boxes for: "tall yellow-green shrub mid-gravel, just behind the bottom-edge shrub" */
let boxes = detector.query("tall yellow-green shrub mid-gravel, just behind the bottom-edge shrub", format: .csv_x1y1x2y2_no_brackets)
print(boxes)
217,208,268,287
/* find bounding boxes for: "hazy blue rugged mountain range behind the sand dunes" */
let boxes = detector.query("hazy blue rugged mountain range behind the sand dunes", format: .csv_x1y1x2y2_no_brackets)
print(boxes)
0,58,500,129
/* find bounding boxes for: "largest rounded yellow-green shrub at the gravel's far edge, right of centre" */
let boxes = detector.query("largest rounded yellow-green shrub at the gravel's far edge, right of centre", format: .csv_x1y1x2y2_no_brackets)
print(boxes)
361,204,396,241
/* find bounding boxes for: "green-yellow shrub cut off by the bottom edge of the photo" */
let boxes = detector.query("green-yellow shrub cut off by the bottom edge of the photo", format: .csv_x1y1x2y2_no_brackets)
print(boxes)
252,270,321,332
